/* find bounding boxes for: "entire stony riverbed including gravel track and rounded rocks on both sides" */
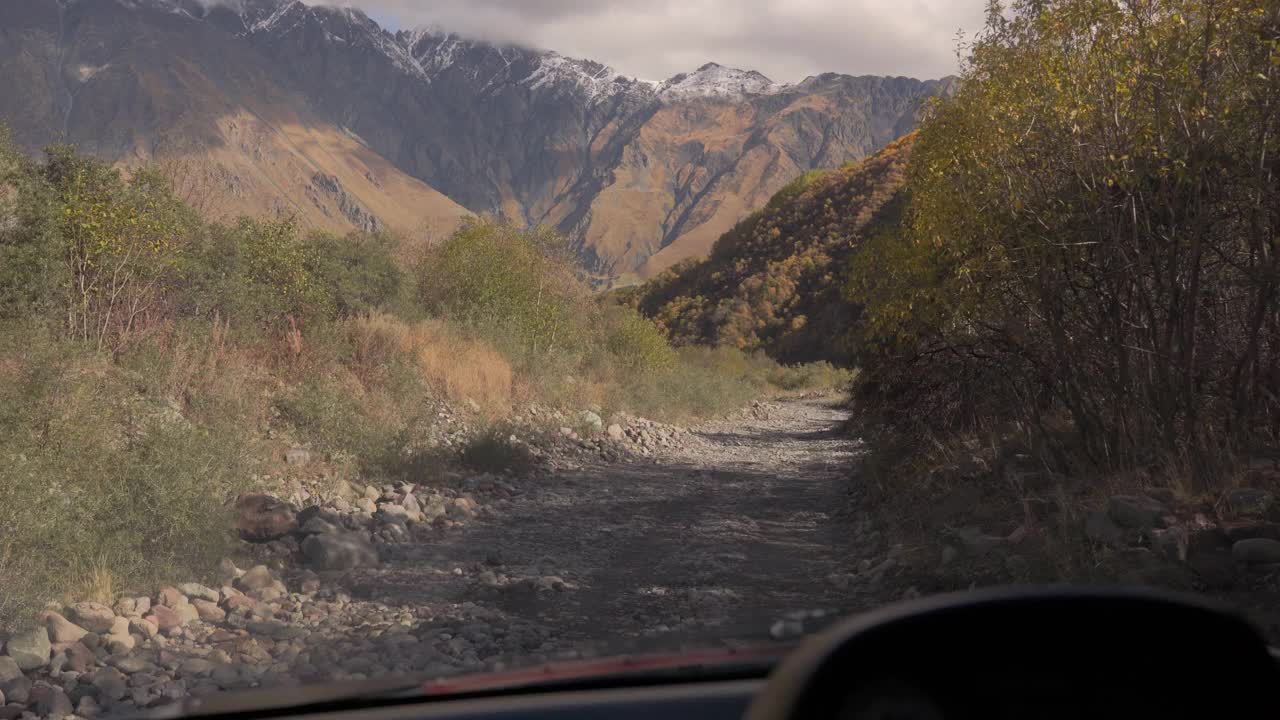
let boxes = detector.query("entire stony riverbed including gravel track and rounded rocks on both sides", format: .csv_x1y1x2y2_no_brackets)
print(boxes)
0,398,1280,720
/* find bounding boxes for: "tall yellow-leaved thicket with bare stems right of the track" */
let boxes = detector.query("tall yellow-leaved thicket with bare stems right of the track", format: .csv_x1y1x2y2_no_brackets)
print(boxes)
851,0,1280,477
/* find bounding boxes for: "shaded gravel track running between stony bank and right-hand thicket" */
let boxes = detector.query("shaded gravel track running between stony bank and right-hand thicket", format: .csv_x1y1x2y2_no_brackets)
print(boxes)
346,398,883,659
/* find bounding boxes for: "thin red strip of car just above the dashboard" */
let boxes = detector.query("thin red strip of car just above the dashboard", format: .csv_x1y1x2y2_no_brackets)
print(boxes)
422,646,790,694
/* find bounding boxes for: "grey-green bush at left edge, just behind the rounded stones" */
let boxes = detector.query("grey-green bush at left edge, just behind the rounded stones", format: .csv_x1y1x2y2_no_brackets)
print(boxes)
0,324,252,626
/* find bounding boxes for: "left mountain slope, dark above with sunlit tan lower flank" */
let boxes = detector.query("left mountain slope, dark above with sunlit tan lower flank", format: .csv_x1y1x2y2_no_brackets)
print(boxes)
0,0,466,231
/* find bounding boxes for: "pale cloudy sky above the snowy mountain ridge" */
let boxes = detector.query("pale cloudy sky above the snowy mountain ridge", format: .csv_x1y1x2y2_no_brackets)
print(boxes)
330,0,984,82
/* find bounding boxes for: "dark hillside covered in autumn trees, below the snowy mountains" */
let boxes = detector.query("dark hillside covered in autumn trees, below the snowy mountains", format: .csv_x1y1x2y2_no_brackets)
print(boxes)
618,135,914,364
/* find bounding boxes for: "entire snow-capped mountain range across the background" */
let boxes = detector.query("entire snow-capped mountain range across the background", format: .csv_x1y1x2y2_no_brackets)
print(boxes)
0,0,950,281
